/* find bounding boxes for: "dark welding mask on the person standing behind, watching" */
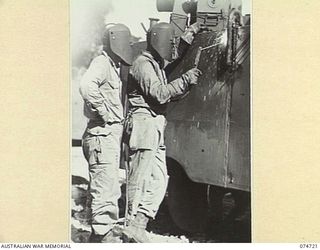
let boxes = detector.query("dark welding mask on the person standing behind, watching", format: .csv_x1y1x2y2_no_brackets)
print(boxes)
102,23,133,65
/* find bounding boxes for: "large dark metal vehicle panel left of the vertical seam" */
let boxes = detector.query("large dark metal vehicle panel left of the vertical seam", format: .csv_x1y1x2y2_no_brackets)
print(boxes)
165,32,230,186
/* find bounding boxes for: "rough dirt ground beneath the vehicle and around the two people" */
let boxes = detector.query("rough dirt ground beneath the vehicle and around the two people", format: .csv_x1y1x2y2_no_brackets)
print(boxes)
71,177,251,243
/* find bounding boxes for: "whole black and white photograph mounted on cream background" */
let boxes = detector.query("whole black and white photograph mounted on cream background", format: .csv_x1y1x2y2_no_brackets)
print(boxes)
70,0,252,243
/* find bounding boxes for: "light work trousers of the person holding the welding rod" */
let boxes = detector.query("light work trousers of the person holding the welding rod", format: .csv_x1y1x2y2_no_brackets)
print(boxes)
127,112,168,219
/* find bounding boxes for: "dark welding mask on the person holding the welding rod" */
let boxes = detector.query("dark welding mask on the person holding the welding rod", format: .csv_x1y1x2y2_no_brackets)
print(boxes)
148,23,174,61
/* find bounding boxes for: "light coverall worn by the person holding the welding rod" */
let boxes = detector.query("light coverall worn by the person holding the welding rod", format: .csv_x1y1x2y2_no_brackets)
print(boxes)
126,51,188,218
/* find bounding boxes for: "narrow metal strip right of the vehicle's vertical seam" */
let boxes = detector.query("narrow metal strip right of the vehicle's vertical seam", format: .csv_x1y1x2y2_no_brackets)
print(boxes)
227,26,251,191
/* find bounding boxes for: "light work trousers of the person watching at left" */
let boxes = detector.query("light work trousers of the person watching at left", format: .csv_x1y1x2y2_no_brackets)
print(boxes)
83,124,123,235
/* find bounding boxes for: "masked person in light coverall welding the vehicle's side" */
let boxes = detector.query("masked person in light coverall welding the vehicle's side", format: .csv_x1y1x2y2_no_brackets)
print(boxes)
123,23,201,242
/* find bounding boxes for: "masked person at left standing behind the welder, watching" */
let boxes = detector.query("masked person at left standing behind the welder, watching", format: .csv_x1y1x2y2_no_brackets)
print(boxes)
80,24,132,242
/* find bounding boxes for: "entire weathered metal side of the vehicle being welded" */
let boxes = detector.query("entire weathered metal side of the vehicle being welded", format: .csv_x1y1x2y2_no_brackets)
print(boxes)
165,23,251,191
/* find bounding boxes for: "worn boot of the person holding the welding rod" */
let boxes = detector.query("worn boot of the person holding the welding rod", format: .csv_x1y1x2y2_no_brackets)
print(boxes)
123,213,150,243
